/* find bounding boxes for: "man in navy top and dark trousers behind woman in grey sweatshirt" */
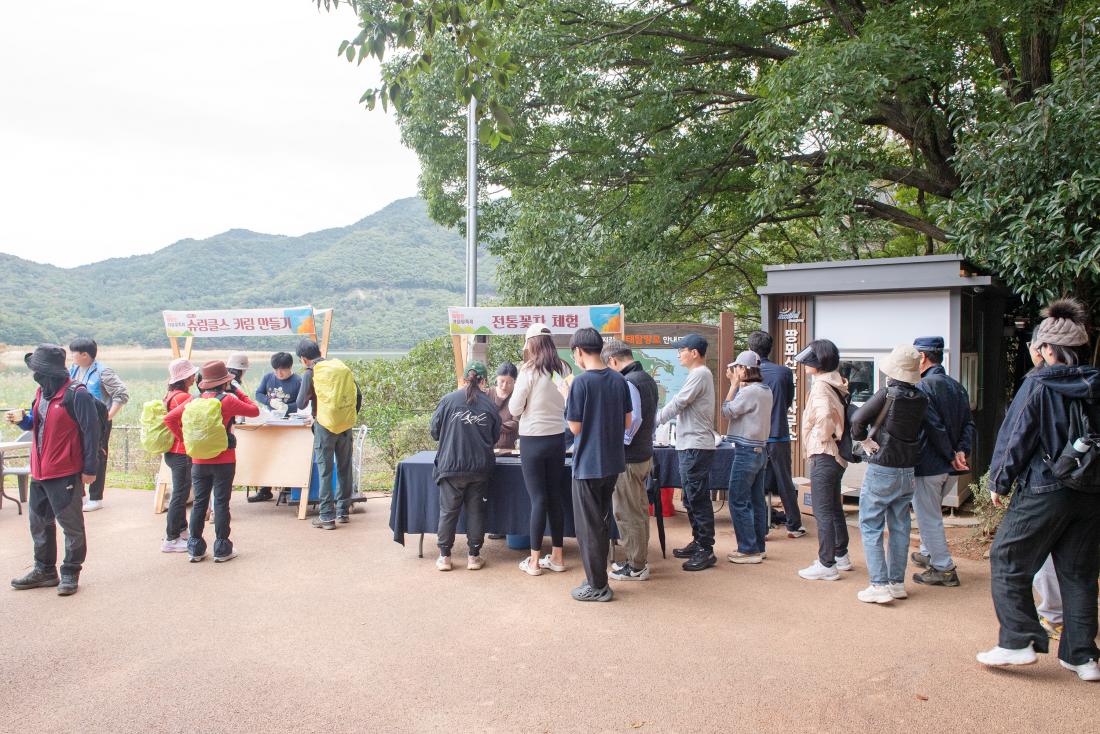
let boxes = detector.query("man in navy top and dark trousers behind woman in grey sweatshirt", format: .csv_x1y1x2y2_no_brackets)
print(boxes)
749,331,806,538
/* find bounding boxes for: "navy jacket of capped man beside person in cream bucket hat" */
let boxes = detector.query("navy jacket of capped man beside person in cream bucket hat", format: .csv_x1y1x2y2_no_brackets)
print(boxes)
916,364,978,476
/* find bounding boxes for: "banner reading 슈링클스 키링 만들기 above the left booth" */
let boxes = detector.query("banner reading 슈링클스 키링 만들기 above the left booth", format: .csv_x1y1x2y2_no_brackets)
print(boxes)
162,306,317,338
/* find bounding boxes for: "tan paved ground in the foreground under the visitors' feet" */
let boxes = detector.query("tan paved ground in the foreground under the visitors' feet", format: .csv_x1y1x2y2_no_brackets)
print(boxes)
0,490,1100,734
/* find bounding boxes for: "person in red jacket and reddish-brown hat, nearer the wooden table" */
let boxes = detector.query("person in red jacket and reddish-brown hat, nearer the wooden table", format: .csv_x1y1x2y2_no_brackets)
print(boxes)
164,361,260,563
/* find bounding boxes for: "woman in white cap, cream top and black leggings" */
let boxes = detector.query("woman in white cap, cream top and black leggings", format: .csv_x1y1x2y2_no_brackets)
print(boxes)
508,322,571,576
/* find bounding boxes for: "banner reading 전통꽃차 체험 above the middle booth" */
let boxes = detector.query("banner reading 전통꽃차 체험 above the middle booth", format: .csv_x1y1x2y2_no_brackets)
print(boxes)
447,304,623,336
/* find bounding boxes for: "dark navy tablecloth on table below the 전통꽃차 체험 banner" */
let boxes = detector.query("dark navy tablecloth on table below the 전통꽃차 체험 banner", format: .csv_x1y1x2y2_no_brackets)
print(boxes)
389,451,589,545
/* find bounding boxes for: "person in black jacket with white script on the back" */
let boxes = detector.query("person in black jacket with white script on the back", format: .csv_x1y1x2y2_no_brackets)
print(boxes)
431,362,501,571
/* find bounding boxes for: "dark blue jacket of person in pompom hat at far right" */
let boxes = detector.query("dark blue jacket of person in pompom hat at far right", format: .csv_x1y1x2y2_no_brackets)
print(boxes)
989,364,1100,494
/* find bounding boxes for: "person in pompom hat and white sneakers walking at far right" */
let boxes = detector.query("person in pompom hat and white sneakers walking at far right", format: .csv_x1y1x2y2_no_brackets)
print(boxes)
977,298,1100,681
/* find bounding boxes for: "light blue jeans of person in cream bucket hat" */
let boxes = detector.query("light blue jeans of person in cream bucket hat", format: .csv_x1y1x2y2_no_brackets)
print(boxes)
859,464,914,587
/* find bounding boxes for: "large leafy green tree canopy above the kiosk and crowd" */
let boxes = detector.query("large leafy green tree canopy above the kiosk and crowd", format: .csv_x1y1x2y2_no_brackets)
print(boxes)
320,0,1100,319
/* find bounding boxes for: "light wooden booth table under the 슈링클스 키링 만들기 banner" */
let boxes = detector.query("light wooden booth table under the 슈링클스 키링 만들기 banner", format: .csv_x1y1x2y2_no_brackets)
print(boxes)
153,421,314,519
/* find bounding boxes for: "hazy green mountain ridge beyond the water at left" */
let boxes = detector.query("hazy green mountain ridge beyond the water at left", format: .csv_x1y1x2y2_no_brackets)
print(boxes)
0,198,495,349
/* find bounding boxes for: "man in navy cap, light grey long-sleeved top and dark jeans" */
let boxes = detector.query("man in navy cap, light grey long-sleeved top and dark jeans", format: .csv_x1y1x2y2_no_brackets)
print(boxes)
657,333,718,571
